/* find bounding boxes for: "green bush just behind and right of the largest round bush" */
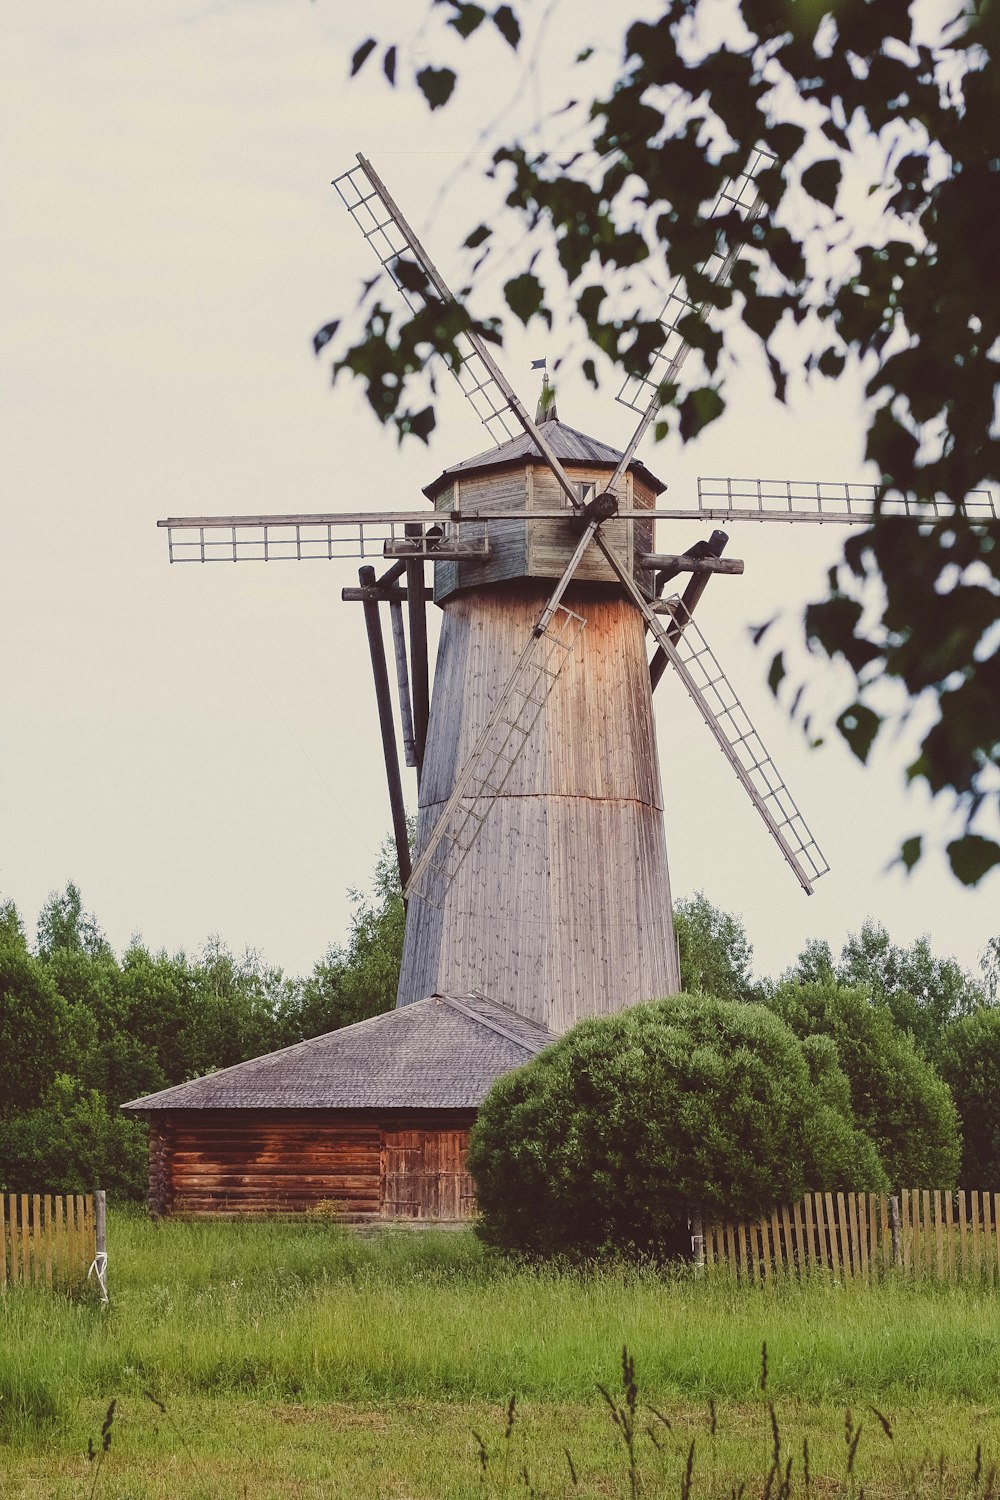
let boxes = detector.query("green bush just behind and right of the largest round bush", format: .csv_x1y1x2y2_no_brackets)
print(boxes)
766,980,961,1188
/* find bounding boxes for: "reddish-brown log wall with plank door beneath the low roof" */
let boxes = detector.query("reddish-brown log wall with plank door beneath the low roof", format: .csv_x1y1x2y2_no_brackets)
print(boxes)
150,1110,474,1221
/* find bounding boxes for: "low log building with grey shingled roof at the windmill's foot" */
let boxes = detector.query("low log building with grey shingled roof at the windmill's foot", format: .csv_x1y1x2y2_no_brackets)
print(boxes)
123,995,555,1223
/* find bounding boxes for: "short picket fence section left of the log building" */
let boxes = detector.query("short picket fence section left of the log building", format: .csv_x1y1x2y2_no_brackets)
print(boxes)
0,1193,105,1287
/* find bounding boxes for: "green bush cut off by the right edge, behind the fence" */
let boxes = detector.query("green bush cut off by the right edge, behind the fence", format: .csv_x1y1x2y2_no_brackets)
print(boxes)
936,1010,1000,1193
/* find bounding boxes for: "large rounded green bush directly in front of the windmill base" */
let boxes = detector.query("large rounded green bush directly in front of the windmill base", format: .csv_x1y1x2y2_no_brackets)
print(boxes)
469,995,885,1256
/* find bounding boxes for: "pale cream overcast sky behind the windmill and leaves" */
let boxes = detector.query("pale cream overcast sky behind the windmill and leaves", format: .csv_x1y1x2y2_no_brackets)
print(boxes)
0,0,1000,974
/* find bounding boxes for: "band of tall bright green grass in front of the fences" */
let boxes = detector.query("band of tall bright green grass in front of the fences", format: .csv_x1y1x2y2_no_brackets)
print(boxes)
0,1215,1000,1436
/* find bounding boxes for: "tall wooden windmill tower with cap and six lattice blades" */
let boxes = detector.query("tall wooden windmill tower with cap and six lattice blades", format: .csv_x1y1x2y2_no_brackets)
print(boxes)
160,153,994,1032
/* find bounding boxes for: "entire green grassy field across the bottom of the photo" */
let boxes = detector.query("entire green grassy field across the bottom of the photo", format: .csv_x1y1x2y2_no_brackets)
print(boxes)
0,1215,1000,1500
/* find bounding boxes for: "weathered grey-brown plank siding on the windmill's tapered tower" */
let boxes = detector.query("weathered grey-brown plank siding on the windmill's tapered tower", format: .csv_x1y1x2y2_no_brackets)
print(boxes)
399,584,679,1032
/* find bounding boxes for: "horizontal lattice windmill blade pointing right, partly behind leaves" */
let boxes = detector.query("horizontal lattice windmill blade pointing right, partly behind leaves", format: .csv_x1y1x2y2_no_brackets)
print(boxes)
699,479,1000,527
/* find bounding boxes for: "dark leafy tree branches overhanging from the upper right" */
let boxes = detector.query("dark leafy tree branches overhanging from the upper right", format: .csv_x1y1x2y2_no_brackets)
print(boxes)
334,0,1000,885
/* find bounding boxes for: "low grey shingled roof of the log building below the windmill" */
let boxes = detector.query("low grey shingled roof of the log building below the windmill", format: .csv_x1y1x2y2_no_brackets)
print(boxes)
121,995,555,1115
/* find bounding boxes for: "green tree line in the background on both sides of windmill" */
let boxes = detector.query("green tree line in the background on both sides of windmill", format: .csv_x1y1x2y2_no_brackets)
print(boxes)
0,845,1000,1199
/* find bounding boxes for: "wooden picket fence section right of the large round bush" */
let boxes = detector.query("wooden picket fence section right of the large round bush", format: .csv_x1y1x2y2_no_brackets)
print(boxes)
693,1188,1000,1283
